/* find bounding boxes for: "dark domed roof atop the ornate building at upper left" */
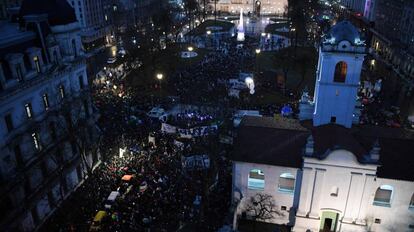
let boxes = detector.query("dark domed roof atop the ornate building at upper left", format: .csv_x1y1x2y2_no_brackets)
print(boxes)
20,0,77,26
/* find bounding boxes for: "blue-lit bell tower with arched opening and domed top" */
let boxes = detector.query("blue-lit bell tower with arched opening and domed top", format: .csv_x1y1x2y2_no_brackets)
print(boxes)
313,21,366,128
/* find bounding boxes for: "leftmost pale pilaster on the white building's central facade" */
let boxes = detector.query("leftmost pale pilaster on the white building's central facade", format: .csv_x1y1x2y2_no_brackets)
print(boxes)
297,167,315,217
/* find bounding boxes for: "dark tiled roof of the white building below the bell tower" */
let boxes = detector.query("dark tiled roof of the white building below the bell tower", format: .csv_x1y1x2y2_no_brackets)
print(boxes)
232,117,414,181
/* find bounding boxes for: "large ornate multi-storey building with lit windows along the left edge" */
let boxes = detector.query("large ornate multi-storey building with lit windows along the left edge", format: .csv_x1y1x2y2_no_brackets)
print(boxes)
0,0,99,231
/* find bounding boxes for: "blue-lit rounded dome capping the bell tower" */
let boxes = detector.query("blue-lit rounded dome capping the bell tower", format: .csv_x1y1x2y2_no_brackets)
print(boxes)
324,21,362,46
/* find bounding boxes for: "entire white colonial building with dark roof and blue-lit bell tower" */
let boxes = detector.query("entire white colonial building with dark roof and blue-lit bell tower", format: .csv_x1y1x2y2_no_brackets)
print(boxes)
232,21,414,232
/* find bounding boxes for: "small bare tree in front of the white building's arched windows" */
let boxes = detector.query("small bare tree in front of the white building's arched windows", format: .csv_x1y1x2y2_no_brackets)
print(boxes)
244,193,283,221
